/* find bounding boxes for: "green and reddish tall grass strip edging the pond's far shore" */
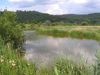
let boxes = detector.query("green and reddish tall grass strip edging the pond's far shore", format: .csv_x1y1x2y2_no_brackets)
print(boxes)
36,29,100,41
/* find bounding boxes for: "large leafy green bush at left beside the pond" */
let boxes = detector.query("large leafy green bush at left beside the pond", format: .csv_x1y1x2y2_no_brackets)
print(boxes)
0,9,24,48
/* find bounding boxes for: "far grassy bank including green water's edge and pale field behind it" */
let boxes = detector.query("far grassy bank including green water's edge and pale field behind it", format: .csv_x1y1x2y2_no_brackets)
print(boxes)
36,26,100,41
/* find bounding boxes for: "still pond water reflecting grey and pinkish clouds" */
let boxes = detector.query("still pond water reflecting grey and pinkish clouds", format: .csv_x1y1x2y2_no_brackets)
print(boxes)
24,31,99,64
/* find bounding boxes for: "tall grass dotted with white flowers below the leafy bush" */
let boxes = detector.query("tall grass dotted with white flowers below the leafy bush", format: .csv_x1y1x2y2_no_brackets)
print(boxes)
0,41,37,75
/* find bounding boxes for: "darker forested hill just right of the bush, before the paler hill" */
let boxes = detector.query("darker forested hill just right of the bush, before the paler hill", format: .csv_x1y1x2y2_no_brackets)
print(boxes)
16,11,65,22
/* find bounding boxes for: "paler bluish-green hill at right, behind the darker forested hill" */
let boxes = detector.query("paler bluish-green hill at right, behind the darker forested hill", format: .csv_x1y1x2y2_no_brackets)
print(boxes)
62,13,100,24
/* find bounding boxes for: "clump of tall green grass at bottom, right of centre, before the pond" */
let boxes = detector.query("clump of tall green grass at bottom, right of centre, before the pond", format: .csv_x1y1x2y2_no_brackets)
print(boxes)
55,59,92,75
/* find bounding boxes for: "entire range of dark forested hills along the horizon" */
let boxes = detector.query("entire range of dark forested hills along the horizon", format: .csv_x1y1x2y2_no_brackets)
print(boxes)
0,10,100,25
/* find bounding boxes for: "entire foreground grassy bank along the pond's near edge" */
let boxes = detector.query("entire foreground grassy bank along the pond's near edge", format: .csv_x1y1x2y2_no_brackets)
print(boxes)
0,41,100,75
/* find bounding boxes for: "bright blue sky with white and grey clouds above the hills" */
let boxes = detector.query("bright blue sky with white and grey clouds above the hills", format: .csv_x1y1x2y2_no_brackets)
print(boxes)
0,0,100,15
